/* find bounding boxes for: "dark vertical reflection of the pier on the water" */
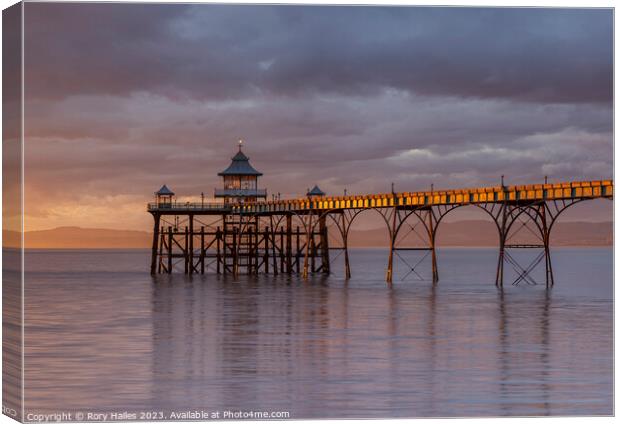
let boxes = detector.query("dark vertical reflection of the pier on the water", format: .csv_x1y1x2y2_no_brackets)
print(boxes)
152,277,568,417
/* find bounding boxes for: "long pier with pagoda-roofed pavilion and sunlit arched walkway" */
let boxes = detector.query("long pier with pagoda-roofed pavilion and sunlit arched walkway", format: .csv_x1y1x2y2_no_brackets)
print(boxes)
147,145,613,287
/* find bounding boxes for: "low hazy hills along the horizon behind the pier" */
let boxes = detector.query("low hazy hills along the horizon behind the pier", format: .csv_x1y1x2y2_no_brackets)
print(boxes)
3,220,613,249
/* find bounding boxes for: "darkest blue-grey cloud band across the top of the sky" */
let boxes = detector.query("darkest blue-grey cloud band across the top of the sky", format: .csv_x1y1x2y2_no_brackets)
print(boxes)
26,3,612,103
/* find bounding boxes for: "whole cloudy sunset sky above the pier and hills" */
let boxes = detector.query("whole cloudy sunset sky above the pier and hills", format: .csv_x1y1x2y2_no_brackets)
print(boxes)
25,3,613,230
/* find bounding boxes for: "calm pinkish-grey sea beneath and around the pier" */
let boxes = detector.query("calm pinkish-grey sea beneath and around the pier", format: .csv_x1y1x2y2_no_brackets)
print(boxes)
25,248,613,418
